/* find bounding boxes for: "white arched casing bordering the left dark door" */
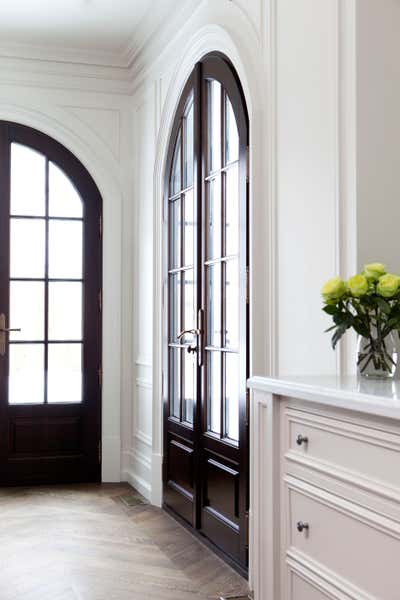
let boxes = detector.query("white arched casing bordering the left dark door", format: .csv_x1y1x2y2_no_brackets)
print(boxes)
0,100,123,481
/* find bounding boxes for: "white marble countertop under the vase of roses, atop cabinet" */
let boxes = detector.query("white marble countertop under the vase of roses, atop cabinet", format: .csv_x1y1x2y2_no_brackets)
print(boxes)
248,375,400,420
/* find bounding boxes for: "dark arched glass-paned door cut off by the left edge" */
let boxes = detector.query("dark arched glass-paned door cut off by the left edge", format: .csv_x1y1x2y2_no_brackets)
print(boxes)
0,121,102,485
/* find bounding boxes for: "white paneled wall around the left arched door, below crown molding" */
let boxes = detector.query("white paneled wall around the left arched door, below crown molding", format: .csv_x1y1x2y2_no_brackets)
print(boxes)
0,59,132,481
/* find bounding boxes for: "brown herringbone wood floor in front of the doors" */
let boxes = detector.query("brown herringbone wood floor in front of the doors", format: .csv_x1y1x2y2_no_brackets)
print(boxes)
0,484,247,600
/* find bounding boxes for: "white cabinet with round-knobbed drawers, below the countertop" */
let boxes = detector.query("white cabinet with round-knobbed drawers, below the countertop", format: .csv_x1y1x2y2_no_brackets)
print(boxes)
251,380,400,600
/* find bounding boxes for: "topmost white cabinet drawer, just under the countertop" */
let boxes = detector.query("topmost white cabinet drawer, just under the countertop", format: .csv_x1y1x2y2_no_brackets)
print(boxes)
283,407,400,500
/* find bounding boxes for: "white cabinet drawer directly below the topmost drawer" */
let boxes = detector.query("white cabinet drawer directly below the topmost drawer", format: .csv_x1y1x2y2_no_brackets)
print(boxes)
285,477,400,600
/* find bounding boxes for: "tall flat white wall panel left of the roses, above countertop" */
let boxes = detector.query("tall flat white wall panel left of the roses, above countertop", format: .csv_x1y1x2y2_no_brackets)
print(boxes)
277,0,339,374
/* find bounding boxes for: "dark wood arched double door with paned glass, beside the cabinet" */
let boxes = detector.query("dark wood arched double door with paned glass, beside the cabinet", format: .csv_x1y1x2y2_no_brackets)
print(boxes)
163,55,249,568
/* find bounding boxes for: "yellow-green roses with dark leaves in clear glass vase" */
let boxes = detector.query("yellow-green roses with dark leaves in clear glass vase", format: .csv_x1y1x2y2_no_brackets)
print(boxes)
321,263,400,377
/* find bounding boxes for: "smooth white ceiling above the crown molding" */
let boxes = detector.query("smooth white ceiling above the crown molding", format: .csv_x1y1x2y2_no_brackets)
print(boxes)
0,0,185,63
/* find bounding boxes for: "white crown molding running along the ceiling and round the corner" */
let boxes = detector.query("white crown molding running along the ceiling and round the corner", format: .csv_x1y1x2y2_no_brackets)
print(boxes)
0,0,198,95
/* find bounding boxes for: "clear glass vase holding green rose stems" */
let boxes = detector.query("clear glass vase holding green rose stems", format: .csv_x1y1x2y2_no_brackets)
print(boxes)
357,329,397,379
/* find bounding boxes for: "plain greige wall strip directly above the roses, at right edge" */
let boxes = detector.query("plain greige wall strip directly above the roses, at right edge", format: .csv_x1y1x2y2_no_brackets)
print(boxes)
357,0,400,272
